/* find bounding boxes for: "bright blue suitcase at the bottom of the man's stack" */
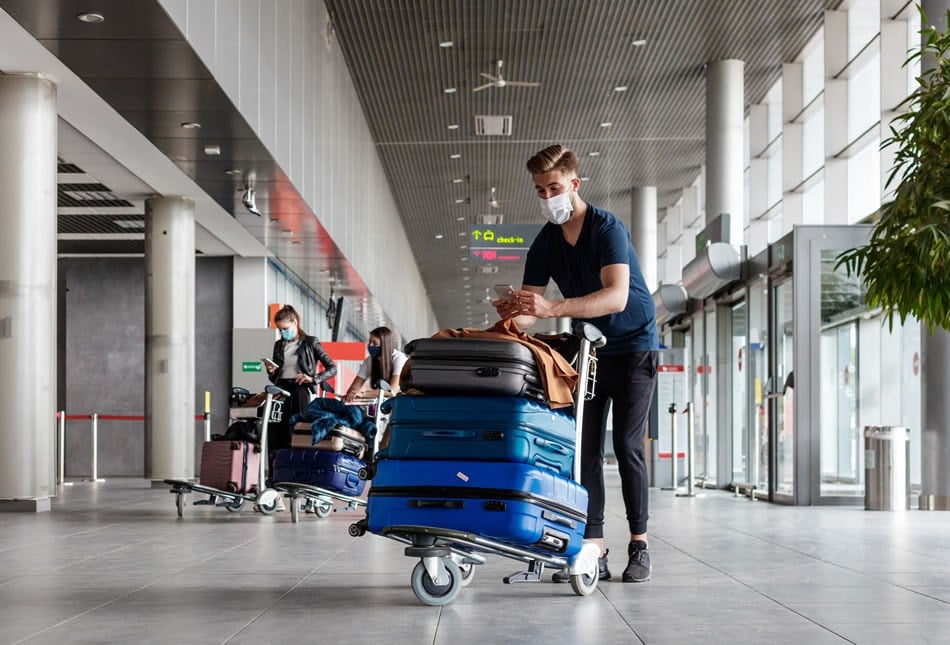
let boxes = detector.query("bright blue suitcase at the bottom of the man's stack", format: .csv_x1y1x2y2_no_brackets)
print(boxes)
366,459,587,557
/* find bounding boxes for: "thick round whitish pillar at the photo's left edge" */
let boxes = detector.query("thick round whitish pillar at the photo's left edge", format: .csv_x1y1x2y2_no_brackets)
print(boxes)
0,74,57,512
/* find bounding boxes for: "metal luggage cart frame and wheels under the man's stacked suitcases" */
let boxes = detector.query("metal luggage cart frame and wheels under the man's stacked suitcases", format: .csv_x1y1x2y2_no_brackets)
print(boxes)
349,323,606,606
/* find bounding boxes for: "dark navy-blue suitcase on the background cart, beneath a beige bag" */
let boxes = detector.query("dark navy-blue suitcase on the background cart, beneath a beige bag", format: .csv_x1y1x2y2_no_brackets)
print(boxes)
271,448,366,495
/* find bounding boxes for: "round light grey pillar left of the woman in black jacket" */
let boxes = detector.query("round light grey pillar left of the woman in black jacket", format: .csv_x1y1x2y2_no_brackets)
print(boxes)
145,197,197,481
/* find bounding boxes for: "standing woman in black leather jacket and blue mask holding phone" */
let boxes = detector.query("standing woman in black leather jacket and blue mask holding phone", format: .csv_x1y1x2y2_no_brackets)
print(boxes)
264,305,336,450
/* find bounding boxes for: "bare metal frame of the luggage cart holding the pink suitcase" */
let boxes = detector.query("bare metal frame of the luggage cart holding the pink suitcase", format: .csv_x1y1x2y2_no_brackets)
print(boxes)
164,385,290,517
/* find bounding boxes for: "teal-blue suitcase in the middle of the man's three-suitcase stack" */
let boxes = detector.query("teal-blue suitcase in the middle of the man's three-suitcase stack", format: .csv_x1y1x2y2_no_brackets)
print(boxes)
386,396,575,477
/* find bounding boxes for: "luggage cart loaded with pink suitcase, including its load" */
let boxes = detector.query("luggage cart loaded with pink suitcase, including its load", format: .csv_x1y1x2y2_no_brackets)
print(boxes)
164,385,290,517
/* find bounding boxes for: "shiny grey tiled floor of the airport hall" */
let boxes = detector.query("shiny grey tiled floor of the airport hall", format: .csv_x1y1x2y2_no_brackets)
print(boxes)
0,473,950,645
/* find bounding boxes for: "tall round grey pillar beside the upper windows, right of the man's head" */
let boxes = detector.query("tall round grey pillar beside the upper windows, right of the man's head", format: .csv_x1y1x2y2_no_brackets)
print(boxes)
706,60,745,244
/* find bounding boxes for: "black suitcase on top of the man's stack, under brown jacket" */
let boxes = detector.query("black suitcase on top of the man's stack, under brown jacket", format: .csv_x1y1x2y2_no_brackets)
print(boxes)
406,338,547,401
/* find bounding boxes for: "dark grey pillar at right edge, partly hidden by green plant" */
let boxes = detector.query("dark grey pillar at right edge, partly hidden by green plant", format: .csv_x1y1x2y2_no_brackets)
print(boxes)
920,0,950,510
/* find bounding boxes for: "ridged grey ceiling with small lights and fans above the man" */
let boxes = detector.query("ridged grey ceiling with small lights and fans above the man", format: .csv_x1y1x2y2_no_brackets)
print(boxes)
326,0,839,326
